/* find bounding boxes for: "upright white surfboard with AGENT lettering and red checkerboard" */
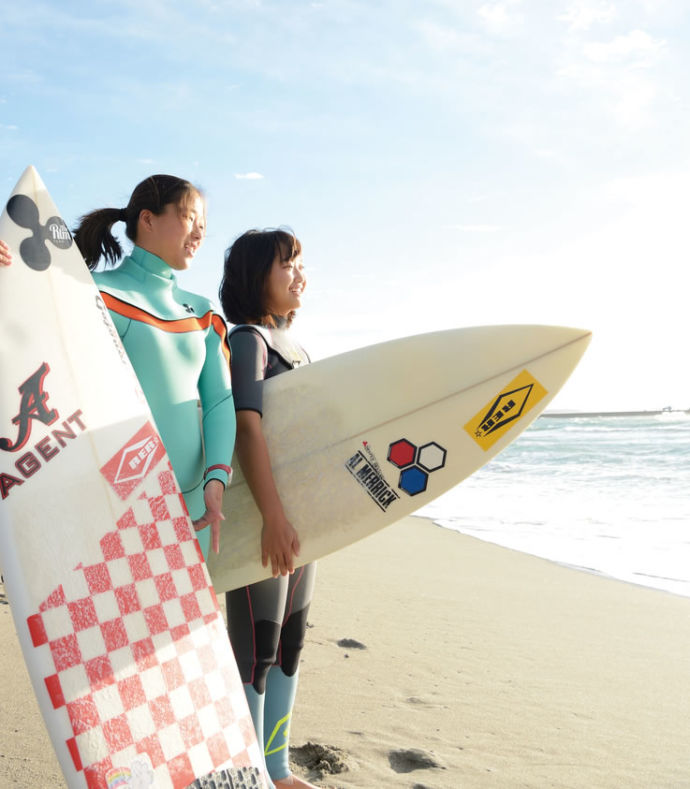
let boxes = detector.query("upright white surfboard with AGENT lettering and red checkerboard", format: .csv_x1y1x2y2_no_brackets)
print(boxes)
0,167,264,789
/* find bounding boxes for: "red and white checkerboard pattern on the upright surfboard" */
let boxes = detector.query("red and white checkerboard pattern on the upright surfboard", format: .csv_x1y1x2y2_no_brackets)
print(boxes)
28,459,260,789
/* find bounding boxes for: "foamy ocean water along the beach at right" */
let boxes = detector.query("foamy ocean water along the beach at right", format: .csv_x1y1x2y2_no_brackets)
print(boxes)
418,412,690,597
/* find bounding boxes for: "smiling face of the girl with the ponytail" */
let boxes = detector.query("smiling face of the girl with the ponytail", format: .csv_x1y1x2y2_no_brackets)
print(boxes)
136,192,206,271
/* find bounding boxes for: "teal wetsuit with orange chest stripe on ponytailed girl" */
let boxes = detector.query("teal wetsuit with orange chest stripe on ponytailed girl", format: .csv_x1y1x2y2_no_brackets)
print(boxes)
93,247,235,556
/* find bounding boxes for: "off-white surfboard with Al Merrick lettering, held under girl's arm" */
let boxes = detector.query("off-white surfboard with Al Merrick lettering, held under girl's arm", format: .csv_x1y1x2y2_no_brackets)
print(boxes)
208,326,591,592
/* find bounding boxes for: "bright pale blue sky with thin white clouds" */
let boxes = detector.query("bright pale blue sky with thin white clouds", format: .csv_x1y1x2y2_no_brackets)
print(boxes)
0,0,690,410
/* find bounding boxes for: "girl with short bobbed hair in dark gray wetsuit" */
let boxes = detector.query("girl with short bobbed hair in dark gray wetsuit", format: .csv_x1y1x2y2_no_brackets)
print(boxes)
219,230,316,789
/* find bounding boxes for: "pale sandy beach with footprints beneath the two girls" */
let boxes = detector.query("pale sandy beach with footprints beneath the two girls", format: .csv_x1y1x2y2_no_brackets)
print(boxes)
0,517,690,789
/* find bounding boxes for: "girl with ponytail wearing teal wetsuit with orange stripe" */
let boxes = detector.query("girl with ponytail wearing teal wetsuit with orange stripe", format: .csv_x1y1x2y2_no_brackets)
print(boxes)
74,175,235,557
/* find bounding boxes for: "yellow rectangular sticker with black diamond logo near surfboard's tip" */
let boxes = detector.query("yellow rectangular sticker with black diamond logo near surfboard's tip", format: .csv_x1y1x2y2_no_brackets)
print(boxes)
465,370,546,450
